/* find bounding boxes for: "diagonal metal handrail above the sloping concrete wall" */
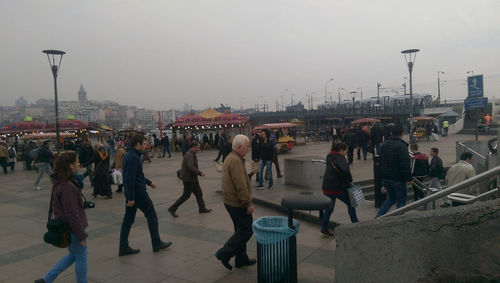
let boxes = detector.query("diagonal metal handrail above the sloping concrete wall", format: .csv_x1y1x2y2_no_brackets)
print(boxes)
378,166,500,218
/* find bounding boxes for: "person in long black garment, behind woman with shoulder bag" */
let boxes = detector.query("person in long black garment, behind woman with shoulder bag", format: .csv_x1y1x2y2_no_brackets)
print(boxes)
92,145,113,199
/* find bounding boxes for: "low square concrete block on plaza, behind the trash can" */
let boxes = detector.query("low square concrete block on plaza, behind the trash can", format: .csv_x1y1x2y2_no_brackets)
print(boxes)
284,156,325,190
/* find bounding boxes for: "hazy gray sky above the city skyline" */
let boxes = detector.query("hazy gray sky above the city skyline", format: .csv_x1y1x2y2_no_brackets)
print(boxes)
0,0,500,109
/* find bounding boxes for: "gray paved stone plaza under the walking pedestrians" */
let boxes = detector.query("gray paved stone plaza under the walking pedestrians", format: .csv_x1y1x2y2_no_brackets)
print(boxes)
0,135,484,282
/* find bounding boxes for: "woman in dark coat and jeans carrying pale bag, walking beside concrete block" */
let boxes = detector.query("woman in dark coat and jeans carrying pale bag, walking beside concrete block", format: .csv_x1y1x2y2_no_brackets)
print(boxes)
321,143,359,236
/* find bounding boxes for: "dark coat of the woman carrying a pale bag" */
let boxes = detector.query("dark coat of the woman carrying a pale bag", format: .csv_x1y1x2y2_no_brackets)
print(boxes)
322,151,352,194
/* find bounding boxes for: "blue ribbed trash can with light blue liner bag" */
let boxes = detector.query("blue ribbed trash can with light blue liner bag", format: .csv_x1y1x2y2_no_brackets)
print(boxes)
252,216,299,283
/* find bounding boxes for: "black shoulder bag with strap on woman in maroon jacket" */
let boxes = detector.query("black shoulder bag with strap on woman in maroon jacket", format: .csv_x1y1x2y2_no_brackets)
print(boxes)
43,188,71,248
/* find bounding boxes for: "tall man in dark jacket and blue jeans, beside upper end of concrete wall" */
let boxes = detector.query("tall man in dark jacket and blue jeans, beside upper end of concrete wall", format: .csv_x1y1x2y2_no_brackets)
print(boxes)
377,125,412,217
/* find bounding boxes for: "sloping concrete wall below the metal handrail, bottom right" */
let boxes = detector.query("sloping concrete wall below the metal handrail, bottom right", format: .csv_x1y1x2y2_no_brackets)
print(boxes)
335,200,500,283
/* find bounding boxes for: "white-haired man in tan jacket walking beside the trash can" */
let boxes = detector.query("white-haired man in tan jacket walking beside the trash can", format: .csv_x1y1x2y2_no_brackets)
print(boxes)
215,135,256,270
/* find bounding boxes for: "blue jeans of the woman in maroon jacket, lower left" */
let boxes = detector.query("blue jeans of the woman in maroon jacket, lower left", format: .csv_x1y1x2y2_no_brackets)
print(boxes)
43,233,89,283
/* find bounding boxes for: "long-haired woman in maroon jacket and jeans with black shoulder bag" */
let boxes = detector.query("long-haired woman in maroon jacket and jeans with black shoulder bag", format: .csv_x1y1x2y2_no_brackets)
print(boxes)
35,151,88,283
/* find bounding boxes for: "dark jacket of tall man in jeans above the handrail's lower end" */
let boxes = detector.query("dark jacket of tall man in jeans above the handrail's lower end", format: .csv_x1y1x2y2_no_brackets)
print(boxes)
379,136,412,181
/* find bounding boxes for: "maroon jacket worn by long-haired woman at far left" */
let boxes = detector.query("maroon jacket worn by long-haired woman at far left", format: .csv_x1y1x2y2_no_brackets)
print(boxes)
51,174,88,241
